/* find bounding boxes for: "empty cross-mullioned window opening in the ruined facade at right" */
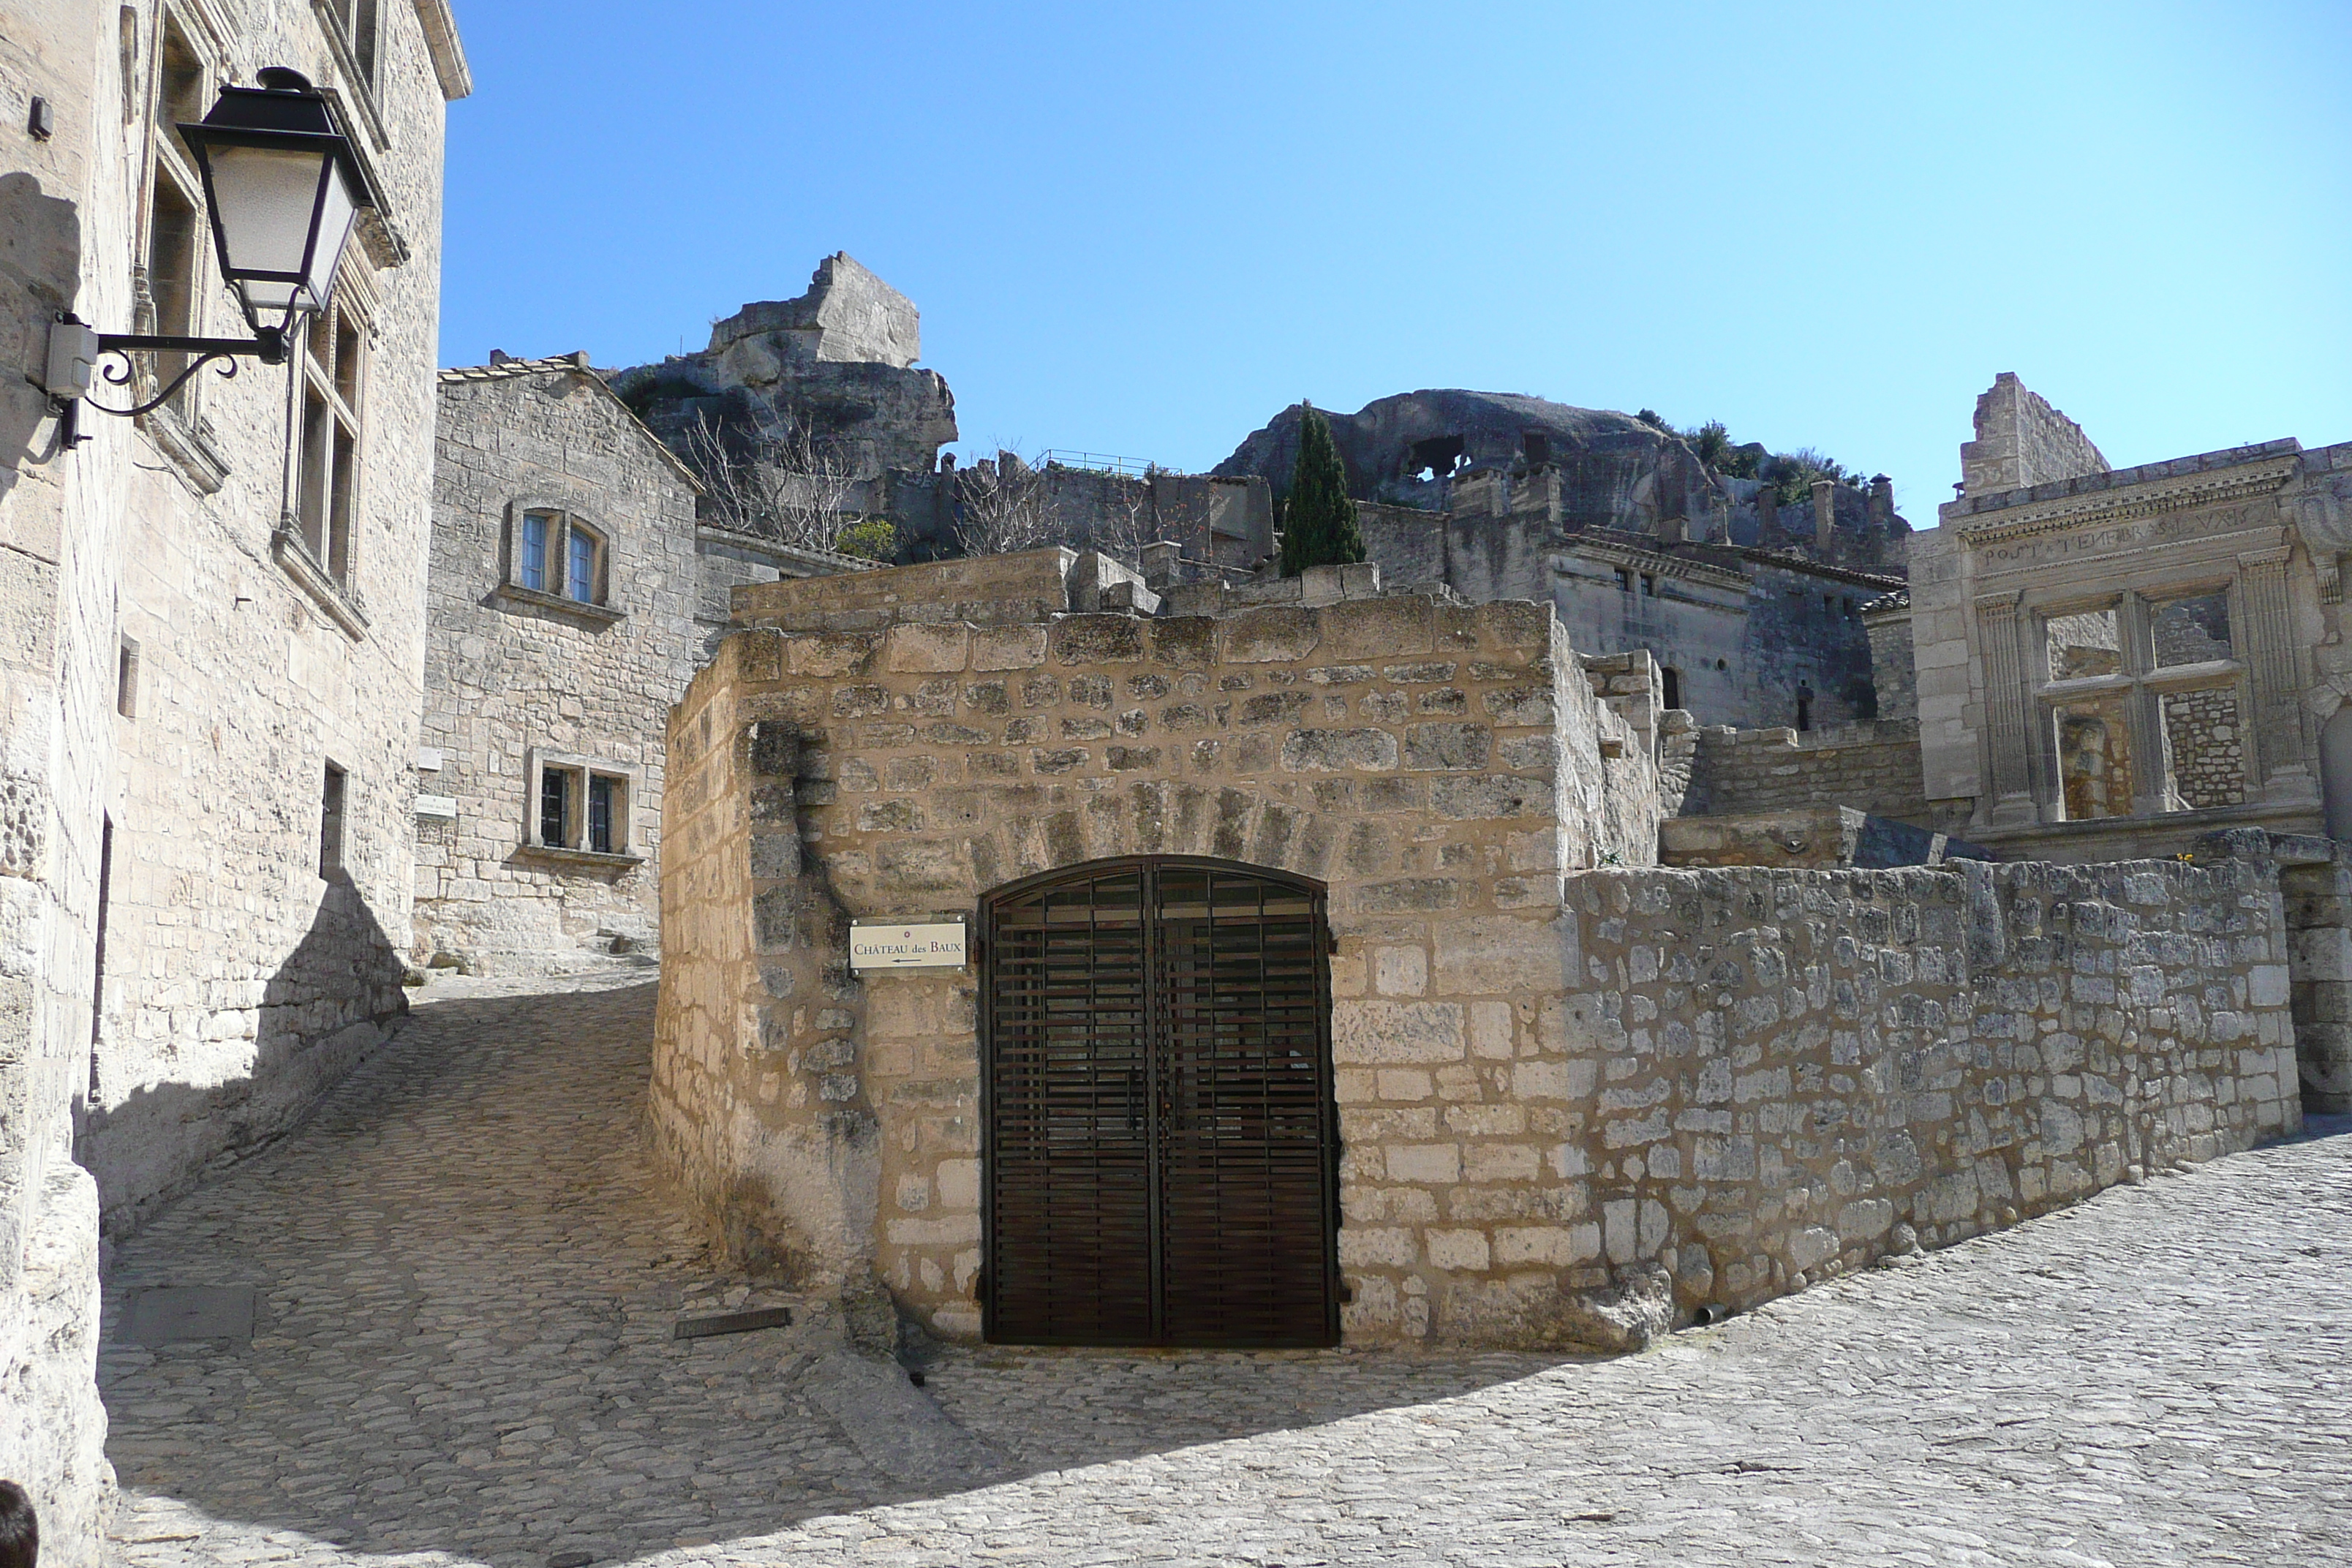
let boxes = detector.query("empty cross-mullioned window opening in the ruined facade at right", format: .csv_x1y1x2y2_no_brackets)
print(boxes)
2039,588,2251,823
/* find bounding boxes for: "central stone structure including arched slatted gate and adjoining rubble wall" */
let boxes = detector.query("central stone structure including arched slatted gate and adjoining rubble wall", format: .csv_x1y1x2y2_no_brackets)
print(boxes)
652,550,2300,1345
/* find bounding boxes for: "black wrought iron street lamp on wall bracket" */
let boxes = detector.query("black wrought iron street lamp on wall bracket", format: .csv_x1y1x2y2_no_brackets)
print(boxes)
47,66,379,425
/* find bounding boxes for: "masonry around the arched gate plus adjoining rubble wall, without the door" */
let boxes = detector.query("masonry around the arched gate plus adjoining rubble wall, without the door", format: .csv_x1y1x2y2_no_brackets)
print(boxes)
649,552,2300,1345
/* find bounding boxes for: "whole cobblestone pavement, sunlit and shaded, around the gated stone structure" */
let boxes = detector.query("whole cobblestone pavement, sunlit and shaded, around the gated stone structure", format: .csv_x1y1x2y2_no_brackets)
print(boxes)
101,978,2352,1568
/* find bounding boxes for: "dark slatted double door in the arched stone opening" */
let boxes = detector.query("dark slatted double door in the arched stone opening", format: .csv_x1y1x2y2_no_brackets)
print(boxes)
981,858,1338,1345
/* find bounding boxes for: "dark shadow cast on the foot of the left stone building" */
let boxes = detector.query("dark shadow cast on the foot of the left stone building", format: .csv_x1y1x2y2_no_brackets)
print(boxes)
78,875,407,1241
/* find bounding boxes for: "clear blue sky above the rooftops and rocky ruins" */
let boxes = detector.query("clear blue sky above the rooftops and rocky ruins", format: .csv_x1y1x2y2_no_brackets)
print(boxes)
440,0,2352,527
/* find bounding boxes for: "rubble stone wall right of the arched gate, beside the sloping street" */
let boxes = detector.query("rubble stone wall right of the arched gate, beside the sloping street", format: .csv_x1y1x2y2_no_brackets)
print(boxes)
1538,860,2300,1305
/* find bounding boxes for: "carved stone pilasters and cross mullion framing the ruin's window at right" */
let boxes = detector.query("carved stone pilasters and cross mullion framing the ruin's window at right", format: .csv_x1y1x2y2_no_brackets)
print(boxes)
2023,569,2261,823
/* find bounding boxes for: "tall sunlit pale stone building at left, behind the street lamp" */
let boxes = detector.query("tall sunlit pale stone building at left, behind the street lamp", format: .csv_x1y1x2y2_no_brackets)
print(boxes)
0,0,468,1564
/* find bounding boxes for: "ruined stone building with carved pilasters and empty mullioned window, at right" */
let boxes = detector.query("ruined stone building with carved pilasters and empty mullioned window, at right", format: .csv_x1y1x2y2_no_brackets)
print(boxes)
1886,374,2352,860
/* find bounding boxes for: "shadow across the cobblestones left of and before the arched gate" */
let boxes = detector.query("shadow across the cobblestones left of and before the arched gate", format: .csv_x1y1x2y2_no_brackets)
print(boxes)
101,980,1569,1568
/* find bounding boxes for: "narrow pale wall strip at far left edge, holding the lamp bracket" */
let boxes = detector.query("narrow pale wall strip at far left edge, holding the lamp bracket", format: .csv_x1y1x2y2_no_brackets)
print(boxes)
0,0,132,1568
